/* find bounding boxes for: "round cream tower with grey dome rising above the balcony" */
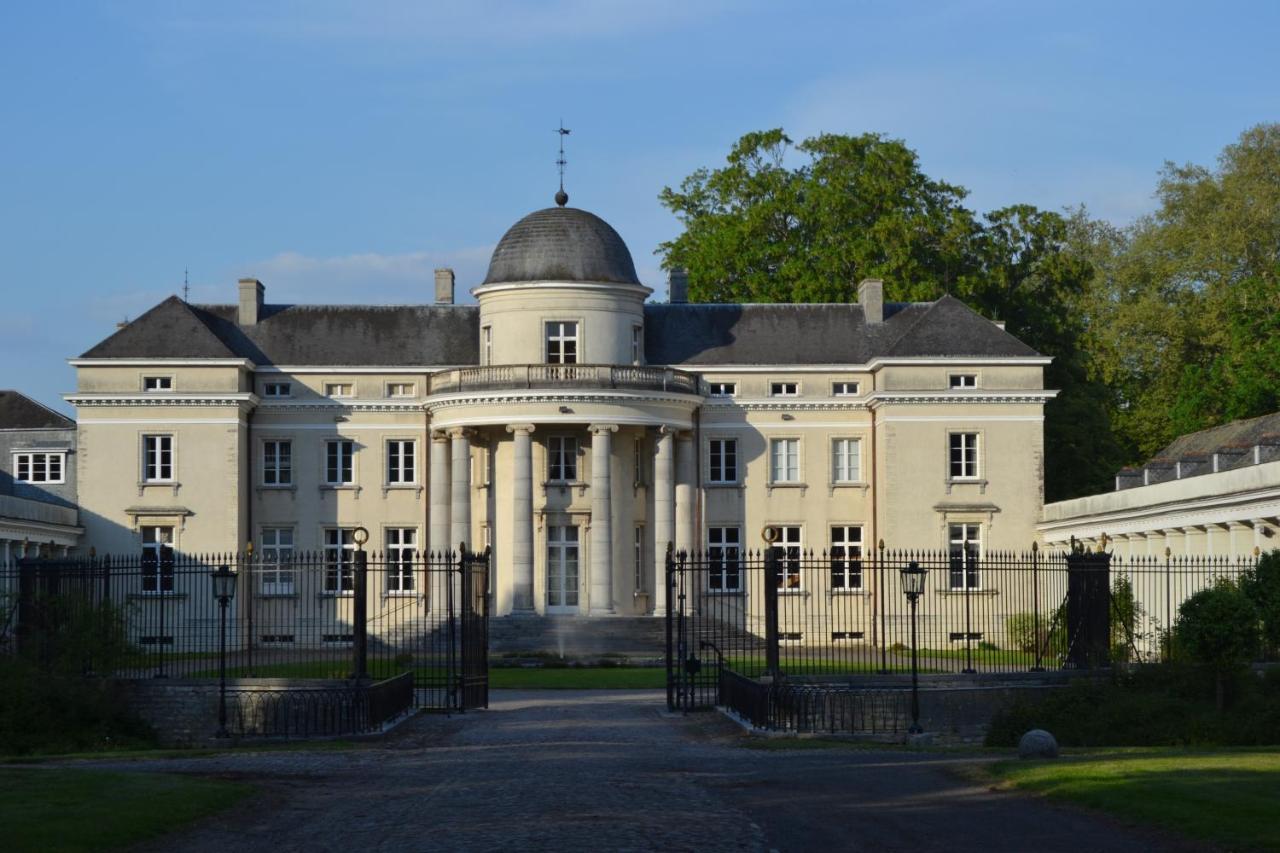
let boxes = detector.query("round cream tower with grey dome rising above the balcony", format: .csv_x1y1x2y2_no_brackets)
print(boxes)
472,199,653,365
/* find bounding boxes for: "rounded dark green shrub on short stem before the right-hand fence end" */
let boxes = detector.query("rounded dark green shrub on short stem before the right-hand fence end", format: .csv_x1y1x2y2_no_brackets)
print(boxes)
1174,578,1258,711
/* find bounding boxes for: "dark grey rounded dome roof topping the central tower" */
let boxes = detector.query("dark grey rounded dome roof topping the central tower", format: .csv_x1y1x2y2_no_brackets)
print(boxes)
484,207,640,284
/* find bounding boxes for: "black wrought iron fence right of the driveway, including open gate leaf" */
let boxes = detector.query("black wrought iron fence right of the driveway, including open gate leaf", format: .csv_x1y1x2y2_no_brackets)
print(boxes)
667,548,1256,716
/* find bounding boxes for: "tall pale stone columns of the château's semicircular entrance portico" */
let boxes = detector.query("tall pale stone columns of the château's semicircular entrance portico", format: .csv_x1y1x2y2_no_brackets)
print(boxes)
428,423,696,615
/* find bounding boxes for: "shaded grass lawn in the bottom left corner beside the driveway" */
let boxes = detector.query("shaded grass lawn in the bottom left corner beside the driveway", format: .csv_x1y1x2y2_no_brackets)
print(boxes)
0,767,253,853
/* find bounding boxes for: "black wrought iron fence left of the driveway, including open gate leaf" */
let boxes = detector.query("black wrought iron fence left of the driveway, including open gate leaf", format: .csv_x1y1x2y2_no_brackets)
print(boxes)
0,549,489,710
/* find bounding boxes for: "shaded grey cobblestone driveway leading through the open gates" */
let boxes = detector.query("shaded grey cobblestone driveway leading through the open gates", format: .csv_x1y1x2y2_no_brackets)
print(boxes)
74,690,1193,853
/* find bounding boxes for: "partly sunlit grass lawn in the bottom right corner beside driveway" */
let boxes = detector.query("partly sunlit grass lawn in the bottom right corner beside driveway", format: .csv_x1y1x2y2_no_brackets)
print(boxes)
988,748,1280,850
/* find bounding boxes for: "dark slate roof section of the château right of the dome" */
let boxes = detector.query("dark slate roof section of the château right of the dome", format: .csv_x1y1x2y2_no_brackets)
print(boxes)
645,296,1037,365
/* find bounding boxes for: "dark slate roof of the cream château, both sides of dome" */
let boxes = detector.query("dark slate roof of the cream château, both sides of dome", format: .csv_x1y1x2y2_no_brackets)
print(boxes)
82,289,1037,366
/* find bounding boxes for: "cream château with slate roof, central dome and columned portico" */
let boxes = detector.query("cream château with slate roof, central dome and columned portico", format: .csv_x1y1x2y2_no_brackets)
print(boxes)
67,195,1053,615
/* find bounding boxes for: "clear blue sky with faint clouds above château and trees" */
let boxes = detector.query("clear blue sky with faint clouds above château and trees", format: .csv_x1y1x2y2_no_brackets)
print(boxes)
0,0,1280,411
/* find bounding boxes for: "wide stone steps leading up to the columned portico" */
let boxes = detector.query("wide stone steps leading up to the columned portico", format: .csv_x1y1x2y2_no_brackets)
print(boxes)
489,616,667,663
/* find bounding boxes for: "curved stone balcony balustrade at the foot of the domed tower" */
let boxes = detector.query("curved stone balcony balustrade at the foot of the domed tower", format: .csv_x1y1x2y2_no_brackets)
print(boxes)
431,364,700,394
